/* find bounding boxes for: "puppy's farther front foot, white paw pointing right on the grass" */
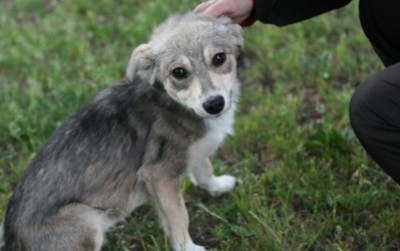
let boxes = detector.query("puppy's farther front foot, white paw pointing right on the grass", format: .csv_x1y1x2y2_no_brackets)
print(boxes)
191,158,236,196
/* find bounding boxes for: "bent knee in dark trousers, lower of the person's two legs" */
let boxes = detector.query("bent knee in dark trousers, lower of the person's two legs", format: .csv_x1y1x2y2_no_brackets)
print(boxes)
350,63,400,184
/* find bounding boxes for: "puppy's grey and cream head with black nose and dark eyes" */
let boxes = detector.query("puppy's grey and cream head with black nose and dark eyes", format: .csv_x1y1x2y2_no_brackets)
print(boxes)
126,13,243,117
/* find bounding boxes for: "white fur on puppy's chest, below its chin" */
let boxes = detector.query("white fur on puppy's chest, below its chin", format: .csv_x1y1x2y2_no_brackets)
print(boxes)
189,109,234,168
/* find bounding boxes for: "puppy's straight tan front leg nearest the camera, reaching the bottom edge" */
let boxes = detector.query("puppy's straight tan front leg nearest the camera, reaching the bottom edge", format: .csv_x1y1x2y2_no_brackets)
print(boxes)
141,168,205,251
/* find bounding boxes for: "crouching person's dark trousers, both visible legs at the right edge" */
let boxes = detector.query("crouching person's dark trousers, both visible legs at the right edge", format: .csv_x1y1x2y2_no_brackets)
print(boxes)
350,0,400,184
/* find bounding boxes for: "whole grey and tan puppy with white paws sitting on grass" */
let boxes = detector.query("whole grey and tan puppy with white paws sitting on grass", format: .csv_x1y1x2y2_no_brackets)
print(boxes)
1,12,243,251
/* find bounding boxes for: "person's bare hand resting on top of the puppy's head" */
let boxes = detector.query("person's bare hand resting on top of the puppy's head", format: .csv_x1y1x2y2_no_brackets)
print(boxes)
194,0,254,23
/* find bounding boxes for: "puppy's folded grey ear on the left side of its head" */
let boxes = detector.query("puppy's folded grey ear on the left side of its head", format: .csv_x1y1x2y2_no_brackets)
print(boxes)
126,44,155,84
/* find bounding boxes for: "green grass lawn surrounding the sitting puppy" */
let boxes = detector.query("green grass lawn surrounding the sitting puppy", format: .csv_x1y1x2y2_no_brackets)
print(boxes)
0,0,400,251
